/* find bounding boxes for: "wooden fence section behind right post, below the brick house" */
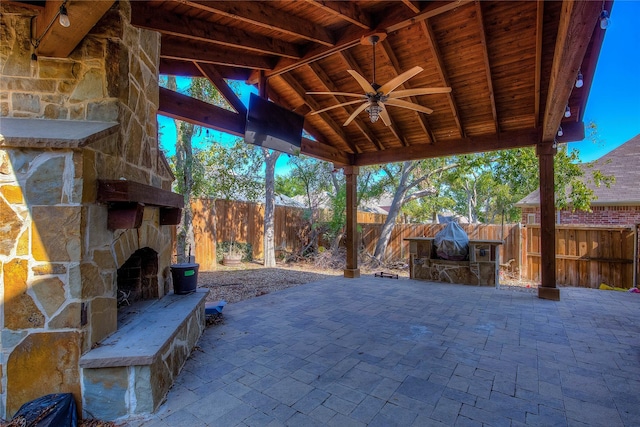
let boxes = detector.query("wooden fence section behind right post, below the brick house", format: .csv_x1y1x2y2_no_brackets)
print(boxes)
525,225,638,289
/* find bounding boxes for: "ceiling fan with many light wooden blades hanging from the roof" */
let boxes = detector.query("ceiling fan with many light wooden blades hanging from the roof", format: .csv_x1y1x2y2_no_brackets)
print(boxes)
307,33,451,126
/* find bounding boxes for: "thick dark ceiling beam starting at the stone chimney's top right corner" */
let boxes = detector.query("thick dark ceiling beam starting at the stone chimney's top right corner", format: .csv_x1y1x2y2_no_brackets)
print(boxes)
131,1,302,59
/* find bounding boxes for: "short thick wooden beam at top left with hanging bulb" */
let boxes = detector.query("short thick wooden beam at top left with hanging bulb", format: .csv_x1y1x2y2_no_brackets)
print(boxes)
35,0,115,58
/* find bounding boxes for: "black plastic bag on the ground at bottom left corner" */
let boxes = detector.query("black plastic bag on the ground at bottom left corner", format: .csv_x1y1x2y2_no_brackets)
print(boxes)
13,393,78,427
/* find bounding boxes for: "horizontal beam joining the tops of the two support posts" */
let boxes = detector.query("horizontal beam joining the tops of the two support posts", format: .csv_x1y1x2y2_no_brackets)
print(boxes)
353,128,540,166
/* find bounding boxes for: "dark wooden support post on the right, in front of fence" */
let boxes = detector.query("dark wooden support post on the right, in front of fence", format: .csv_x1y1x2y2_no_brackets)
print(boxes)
537,143,560,301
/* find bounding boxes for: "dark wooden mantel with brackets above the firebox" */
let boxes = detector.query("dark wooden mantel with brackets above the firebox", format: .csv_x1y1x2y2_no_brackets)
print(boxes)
97,180,184,230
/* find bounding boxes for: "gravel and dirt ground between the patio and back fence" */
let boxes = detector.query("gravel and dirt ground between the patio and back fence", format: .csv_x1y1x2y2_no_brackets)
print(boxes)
198,263,409,303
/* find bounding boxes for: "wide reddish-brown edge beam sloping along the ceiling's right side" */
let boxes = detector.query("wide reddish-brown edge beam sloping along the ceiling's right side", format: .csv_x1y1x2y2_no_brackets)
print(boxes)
542,1,602,142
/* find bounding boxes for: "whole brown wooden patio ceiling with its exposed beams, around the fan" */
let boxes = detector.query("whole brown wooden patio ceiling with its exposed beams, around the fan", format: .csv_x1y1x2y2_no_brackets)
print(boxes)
26,0,612,165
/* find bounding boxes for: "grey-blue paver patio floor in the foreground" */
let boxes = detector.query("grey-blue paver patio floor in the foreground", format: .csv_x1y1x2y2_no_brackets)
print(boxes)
127,277,640,427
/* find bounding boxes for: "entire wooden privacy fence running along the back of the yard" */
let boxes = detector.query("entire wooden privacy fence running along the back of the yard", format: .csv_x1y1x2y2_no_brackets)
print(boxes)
192,199,639,288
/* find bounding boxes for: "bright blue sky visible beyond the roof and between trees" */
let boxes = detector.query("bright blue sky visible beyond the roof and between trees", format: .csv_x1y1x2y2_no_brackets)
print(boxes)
158,0,640,174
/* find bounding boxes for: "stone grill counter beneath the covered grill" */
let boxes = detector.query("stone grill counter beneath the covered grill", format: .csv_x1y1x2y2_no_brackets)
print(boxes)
405,237,502,286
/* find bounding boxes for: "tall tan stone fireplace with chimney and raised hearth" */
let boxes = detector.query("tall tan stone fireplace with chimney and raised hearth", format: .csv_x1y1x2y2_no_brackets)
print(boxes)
0,1,204,420
